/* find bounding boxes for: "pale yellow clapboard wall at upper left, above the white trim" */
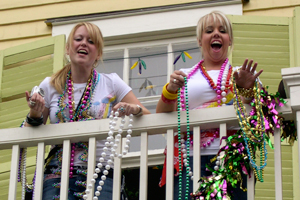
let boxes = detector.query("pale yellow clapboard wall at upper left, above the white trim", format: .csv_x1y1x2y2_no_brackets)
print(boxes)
0,0,213,50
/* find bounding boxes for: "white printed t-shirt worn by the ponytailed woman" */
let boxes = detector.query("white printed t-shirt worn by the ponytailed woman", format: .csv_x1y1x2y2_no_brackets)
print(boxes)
40,73,131,165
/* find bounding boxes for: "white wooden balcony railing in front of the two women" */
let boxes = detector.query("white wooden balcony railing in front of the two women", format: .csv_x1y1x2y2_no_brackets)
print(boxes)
0,68,300,200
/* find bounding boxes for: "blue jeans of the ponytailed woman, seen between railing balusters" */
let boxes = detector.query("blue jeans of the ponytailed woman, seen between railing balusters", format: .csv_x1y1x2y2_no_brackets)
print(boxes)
43,175,113,200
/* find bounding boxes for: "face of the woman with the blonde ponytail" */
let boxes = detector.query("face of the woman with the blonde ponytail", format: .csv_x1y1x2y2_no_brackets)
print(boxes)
67,26,100,69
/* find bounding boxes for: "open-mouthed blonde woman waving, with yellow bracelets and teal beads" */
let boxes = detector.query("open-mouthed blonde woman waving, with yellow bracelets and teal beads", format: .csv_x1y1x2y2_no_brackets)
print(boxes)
156,11,262,200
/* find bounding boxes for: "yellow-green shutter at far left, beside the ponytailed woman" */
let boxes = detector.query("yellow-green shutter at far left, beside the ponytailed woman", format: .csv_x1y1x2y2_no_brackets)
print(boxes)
0,35,65,199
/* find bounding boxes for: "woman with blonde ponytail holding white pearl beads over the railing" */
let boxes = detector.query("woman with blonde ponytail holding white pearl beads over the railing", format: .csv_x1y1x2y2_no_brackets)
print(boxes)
24,22,150,200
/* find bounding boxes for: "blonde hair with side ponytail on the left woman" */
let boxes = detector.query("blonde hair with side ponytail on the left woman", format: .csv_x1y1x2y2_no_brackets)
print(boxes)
50,22,104,94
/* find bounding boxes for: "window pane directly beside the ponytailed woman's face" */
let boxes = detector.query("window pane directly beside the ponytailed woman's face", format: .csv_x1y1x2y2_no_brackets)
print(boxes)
96,50,124,79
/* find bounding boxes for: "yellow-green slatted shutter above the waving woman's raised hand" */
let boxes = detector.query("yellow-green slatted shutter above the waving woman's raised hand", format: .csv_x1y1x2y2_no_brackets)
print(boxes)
232,21,290,93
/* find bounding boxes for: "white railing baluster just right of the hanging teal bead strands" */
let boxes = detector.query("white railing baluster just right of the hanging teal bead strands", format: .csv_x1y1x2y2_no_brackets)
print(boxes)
193,126,201,192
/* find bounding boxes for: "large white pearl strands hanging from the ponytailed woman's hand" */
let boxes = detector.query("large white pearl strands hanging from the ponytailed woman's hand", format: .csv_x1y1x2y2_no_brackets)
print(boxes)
83,111,133,200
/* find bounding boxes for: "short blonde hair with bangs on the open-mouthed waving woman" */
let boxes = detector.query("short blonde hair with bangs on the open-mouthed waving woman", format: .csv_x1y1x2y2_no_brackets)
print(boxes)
196,11,233,55
